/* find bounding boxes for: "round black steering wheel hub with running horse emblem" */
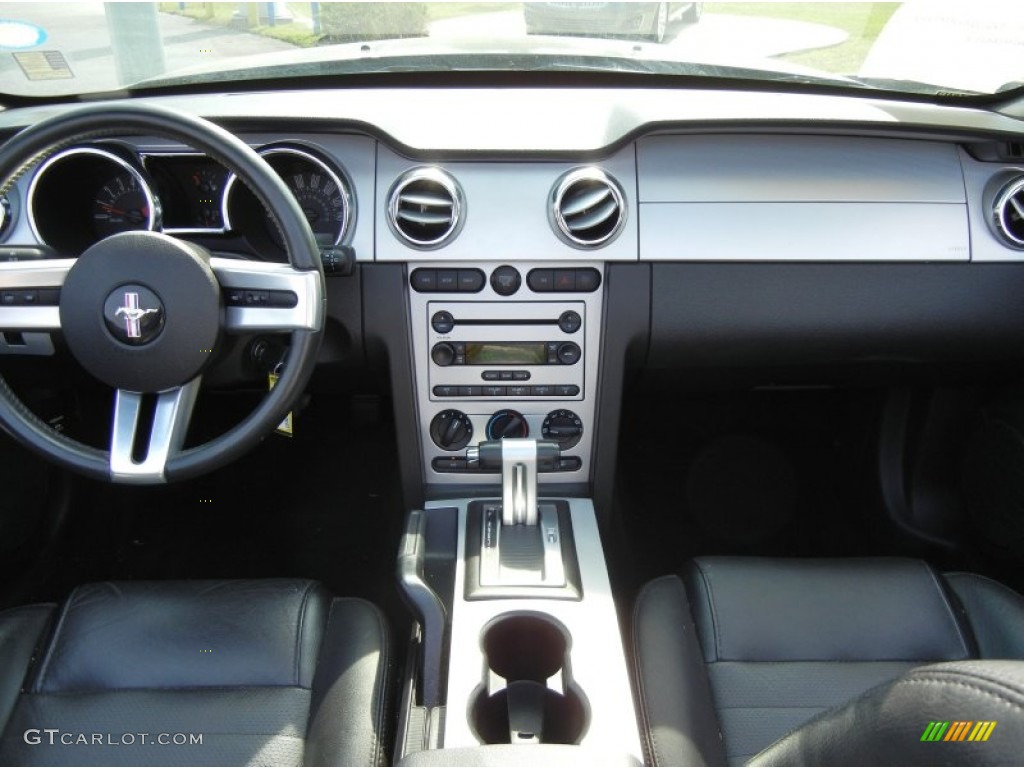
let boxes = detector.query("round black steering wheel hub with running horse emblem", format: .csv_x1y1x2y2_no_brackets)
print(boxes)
59,231,220,392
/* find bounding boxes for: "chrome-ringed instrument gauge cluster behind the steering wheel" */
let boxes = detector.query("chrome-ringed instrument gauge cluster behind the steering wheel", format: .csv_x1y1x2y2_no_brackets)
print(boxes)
24,142,354,260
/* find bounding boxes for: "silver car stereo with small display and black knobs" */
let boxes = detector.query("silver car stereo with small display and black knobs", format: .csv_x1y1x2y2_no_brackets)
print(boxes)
425,301,587,400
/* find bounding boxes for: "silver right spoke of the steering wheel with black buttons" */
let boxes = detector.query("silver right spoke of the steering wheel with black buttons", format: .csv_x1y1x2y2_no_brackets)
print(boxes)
210,257,324,333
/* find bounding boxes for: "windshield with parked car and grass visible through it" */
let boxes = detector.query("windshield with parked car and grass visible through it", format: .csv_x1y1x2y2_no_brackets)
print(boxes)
0,0,1024,97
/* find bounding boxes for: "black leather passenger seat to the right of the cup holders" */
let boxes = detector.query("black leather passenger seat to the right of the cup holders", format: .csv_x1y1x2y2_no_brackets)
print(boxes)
633,557,1024,765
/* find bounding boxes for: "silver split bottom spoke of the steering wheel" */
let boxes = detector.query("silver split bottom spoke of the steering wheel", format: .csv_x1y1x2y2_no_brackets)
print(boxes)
111,377,201,484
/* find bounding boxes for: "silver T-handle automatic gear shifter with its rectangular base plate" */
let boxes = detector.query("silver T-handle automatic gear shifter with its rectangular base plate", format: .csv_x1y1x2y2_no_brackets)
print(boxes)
466,439,578,599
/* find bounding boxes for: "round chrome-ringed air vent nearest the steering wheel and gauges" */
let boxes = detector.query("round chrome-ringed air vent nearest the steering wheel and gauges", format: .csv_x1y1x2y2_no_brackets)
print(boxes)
388,168,465,249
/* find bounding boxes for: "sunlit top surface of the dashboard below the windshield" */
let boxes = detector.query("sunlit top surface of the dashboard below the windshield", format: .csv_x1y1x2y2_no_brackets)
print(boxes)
0,87,1024,156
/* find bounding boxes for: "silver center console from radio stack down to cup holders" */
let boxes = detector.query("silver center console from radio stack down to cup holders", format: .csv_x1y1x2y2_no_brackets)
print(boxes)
394,262,642,765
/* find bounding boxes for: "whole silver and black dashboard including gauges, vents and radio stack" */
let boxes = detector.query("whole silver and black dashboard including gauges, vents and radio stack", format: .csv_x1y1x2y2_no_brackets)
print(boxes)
0,88,1024,489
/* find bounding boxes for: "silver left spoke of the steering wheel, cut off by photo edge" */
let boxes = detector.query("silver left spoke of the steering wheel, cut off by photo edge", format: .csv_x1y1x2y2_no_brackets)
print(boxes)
0,259,75,332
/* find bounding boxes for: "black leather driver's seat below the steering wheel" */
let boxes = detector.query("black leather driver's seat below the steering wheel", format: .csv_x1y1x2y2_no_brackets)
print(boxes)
0,580,390,765
